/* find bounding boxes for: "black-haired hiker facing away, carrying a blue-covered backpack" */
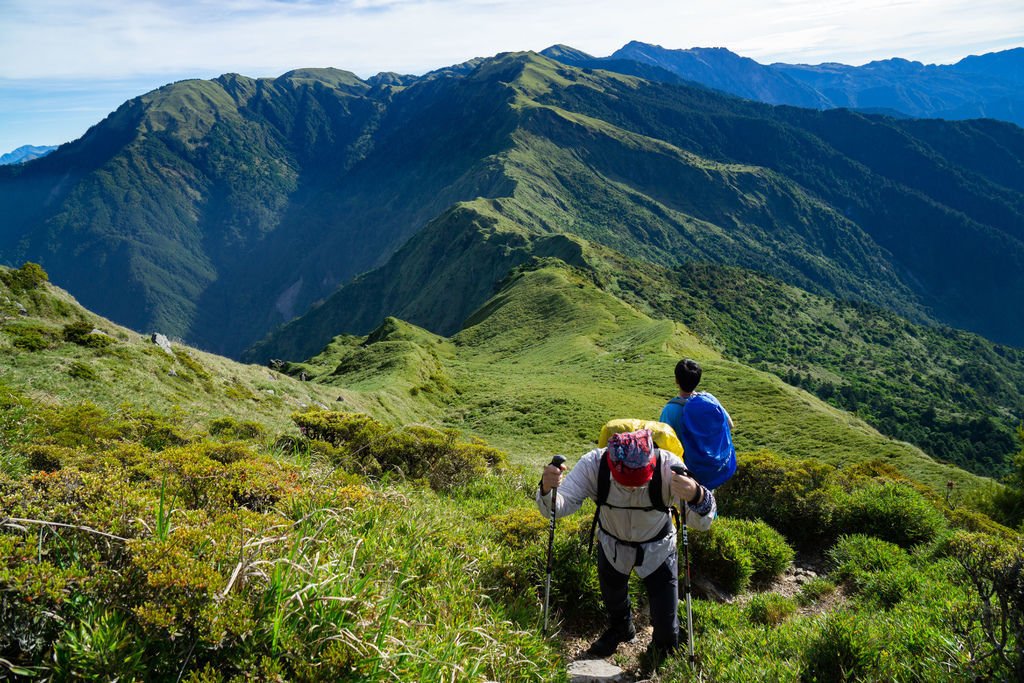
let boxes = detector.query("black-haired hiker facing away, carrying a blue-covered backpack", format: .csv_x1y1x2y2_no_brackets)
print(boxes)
658,358,736,489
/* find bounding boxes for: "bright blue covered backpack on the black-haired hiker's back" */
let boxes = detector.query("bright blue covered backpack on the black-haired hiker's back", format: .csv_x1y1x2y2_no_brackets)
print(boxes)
669,393,736,488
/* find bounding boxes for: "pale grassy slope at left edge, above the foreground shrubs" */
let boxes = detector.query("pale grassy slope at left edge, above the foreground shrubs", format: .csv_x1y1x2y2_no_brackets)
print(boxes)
0,268,362,428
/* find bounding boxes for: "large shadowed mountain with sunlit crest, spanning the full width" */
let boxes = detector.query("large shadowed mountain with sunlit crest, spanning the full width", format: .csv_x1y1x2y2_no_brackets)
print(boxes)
0,53,1024,354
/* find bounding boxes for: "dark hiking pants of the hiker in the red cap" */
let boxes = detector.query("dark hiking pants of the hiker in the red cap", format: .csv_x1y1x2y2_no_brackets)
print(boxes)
597,545,679,651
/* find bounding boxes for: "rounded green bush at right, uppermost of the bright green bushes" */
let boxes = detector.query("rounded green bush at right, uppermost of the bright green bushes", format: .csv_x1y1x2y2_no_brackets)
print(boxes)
838,481,947,548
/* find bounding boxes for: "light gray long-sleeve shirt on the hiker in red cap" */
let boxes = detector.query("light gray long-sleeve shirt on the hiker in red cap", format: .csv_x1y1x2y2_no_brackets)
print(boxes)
537,449,718,578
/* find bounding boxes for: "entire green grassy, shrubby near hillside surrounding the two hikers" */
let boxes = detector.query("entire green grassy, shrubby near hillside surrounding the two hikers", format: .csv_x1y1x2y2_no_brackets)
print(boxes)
0,259,1019,681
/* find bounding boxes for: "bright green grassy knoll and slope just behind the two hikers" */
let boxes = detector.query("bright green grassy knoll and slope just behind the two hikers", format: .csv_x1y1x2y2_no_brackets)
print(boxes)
291,260,983,497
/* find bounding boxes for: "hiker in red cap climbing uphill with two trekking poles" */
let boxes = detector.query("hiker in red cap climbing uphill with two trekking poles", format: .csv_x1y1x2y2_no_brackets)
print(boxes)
537,423,717,660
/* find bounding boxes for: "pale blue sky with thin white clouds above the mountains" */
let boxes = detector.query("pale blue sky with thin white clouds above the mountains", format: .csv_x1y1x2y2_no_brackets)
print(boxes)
0,0,1024,154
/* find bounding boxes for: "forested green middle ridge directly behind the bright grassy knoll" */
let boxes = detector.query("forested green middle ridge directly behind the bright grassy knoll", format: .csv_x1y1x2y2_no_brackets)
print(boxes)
246,191,1024,474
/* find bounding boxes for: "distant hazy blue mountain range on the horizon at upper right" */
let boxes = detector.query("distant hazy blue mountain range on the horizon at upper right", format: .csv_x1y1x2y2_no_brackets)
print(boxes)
543,41,1024,127
